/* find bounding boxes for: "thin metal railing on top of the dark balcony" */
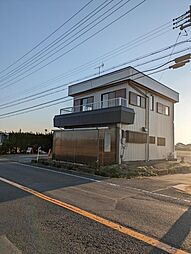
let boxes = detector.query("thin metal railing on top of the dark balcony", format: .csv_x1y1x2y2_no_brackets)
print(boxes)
60,97,128,115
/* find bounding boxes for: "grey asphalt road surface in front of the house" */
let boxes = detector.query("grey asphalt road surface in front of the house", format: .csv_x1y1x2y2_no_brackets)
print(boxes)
0,159,191,254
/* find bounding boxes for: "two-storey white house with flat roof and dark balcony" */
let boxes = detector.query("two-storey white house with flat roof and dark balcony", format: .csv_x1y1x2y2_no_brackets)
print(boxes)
53,67,179,165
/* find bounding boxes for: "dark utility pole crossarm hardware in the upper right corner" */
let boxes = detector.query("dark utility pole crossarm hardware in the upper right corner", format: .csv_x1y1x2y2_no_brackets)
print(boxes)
173,5,191,31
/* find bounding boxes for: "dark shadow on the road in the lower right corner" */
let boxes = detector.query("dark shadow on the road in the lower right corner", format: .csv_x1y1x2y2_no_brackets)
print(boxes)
150,207,191,254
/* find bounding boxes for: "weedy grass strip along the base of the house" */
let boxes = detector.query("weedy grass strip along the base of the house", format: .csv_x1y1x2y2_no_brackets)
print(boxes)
32,159,191,179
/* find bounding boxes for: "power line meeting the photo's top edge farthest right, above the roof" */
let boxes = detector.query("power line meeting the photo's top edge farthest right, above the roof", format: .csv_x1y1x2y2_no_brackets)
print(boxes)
2,0,146,88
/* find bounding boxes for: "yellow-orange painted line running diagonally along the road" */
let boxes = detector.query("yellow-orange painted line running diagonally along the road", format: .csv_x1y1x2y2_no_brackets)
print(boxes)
0,177,188,254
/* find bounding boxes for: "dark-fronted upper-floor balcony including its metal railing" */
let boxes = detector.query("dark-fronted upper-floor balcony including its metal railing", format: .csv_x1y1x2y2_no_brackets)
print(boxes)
54,97,135,128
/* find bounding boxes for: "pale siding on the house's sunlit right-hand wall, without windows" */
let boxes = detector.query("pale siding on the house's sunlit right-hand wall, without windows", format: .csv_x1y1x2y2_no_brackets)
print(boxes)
122,88,174,161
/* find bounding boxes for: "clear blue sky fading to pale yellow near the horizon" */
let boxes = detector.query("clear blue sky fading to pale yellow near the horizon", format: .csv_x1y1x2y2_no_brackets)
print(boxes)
0,0,191,143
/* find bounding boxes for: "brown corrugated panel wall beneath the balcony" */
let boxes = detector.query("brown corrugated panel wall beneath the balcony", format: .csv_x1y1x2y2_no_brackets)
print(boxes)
53,128,116,165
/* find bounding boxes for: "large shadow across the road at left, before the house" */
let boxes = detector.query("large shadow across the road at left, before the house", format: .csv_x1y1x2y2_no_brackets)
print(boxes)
0,162,104,203
